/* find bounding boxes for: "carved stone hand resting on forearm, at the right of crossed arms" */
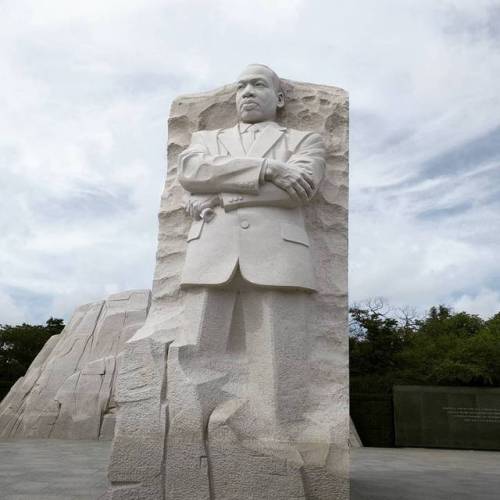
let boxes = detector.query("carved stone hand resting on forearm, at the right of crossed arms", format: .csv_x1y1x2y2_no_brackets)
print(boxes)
264,160,314,203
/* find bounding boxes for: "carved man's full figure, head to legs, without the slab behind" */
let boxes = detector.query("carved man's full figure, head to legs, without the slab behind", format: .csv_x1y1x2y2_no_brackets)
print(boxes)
166,65,325,500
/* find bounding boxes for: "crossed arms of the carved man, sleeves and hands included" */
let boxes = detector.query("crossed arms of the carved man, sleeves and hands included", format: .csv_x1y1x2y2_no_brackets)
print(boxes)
178,132,325,219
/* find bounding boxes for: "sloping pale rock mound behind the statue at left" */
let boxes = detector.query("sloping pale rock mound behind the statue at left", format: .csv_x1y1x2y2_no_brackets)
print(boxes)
0,290,151,439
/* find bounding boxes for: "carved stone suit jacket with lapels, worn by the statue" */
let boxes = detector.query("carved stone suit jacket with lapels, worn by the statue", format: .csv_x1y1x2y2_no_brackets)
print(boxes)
178,122,325,291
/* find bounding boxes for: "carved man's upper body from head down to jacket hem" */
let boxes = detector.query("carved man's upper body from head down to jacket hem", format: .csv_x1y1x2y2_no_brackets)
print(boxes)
178,65,325,290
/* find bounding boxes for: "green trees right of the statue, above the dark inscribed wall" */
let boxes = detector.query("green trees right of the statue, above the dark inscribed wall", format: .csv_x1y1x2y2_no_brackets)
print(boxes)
349,299,500,392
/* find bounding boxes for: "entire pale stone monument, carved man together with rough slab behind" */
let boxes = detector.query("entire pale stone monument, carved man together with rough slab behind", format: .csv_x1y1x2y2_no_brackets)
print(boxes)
105,64,349,500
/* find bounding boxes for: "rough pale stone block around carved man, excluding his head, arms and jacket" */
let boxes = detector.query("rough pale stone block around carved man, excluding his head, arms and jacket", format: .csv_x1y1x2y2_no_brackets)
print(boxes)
108,81,349,500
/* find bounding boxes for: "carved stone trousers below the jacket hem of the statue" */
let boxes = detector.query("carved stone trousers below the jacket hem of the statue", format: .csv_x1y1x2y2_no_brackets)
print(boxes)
166,270,311,500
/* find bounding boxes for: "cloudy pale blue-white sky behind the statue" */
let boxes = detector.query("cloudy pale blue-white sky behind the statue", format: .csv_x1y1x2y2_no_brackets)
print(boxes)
0,0,500,324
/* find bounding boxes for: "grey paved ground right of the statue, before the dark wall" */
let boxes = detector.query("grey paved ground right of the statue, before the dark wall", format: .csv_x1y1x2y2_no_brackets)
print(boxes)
351,448,500,500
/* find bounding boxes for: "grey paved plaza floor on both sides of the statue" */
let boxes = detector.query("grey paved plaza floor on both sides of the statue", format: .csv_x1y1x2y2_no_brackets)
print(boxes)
0,440,500,500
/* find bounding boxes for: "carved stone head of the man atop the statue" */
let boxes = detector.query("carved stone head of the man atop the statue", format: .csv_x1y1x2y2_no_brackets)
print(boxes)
236,66,284,123
